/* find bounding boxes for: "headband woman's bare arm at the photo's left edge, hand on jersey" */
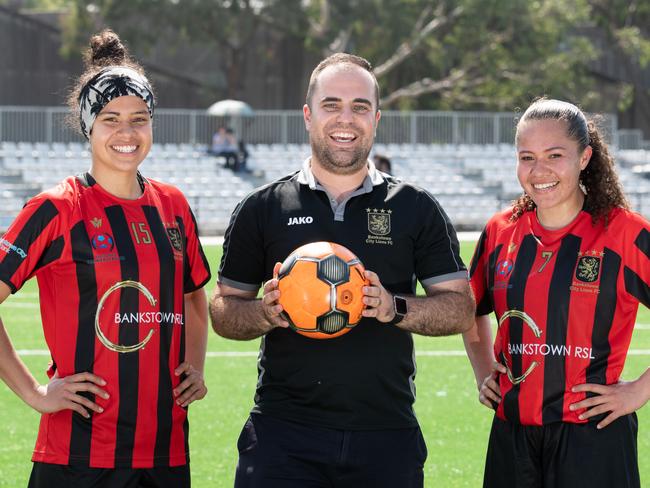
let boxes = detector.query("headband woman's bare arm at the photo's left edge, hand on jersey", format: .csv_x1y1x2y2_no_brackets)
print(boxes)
0,282,108,417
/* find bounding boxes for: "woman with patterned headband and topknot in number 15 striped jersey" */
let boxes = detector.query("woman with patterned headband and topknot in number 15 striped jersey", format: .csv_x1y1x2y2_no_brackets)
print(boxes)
0,30,210,488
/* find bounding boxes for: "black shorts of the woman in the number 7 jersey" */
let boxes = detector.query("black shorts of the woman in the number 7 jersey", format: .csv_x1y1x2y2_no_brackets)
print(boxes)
483,413,641,488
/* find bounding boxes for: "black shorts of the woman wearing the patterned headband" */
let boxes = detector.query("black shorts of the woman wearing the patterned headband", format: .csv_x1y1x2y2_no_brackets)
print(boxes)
28,463,191,488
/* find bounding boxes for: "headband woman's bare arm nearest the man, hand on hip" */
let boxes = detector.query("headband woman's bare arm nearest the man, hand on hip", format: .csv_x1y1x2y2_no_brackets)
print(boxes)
174,288,208,407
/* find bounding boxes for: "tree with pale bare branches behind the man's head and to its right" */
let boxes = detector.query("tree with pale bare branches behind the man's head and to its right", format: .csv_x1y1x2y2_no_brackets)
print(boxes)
302,0,597,110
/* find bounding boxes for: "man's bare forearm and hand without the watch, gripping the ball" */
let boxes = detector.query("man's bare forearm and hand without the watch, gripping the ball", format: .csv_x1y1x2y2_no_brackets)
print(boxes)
210,263,289,341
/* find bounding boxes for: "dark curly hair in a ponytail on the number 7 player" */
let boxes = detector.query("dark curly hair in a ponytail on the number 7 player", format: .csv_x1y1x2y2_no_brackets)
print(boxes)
510,98,629,225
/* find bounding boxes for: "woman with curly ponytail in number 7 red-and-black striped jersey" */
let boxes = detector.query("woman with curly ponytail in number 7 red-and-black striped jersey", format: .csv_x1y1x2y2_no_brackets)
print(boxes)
464,99,650,488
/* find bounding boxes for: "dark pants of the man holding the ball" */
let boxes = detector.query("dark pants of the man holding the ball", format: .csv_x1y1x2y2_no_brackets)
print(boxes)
235,414,427,488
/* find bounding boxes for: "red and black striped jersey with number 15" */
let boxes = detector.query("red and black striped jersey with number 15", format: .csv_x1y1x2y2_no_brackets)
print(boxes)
0,174,210,468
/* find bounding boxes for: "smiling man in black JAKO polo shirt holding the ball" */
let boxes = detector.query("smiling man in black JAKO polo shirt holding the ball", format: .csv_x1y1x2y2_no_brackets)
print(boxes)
211,54,474,488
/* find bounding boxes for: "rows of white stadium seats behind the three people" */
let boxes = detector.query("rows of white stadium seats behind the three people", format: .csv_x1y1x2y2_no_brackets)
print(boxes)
0,142,650,234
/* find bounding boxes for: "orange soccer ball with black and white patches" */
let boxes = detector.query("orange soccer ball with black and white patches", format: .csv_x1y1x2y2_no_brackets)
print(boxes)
278,242,368,339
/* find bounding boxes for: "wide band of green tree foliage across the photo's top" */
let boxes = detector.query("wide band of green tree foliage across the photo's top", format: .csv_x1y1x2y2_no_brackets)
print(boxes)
49,0,650,110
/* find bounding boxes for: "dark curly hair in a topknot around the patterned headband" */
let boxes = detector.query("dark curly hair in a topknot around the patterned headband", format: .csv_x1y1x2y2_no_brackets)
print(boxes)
67,29,151,132
